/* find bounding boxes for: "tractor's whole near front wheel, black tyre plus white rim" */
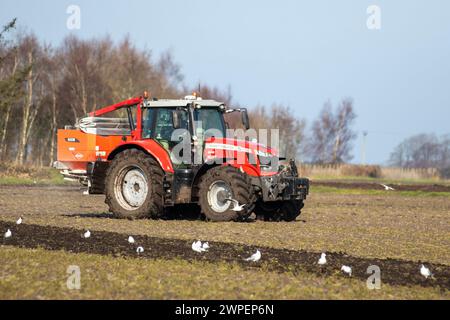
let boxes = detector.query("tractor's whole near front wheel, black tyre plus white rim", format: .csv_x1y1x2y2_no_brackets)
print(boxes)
199,166,256,221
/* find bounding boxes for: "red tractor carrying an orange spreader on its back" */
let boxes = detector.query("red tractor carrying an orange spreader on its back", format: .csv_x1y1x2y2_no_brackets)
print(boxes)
55,93,309,221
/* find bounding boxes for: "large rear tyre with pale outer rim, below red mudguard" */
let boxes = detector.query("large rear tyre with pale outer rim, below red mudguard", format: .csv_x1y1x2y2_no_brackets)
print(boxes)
105,149,164,219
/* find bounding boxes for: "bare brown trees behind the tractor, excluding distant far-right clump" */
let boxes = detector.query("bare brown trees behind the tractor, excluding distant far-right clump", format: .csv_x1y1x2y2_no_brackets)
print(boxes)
0,20,356,166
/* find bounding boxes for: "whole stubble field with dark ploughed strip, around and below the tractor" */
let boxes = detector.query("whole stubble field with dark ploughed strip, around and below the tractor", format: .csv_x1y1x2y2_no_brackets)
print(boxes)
0,182,450,299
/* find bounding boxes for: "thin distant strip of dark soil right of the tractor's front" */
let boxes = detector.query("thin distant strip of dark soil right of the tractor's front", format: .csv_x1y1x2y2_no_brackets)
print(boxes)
311,181,450,192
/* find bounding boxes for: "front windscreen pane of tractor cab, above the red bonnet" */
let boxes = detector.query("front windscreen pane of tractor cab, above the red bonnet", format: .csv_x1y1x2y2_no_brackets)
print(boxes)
194,108,226,139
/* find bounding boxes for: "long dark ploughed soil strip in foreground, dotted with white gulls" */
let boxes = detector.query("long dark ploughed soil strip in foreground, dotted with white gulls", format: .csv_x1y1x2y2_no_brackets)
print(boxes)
0,221,450,290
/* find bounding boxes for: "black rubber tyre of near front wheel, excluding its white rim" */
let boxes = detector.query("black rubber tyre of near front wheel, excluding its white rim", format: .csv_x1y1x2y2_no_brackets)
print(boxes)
199,166,256,221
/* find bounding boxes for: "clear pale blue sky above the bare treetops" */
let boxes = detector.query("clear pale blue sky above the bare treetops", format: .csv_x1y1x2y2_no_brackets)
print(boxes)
0,0,450,163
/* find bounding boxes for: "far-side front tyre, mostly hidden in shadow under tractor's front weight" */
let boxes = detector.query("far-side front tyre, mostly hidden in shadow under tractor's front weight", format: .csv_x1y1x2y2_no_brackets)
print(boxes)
255,200,304,221
